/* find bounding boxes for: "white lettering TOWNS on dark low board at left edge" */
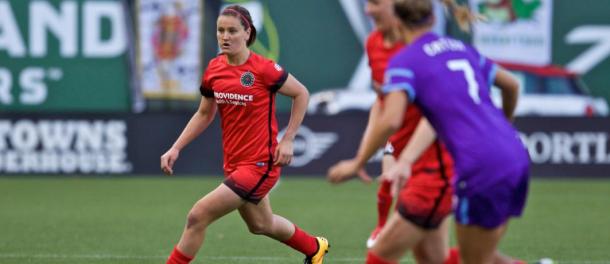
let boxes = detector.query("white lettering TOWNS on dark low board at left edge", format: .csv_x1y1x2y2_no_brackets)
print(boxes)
0,119,132,174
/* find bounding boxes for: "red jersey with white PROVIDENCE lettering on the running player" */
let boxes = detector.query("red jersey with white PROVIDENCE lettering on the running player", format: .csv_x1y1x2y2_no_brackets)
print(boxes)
200,51,288,172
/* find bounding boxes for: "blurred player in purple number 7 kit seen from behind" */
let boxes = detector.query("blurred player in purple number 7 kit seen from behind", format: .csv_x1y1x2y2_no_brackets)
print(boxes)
329,0,529,264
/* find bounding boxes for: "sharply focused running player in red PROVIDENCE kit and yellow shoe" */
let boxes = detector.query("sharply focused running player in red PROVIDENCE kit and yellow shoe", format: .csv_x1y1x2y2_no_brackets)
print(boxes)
161,5,329,264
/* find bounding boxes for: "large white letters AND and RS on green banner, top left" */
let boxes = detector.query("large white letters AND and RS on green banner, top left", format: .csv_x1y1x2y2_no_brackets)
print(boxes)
0,0,127,105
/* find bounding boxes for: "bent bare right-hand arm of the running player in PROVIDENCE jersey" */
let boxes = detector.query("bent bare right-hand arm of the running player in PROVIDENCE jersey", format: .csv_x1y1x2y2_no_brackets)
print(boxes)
274,74,309,166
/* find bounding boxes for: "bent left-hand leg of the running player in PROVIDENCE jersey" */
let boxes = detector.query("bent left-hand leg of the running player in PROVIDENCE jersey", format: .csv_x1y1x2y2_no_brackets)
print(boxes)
167,184,244,264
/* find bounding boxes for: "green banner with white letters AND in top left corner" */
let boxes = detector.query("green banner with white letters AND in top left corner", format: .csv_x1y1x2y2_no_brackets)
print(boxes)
0,0,131,112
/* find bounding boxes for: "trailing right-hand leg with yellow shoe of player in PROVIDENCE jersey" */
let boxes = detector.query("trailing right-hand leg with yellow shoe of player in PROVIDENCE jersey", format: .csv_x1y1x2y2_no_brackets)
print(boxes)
239,196,329,263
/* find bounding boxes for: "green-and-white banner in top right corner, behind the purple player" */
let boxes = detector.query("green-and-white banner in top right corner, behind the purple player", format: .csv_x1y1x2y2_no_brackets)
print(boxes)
460,0,610,106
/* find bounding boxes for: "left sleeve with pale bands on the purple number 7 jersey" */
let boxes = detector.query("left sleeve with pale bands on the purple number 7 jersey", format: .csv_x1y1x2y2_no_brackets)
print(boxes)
382,56,417,101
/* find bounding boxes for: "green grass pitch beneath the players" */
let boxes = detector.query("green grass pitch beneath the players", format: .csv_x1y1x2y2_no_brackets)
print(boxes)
0,176,610,264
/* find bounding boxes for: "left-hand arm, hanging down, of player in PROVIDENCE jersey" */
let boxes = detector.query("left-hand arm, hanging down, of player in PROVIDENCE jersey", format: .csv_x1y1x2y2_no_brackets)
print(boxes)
161,96,216,175
